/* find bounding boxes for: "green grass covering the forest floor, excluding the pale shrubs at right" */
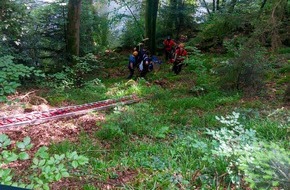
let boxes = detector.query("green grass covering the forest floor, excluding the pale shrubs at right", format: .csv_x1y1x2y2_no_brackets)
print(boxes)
42,51,289,189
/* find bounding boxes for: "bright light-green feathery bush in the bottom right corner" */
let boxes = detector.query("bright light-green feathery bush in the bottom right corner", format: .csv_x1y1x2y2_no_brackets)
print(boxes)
239,143,290,189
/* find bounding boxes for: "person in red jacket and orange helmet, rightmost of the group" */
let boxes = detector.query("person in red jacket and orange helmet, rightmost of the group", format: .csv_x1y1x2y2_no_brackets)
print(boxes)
172,43,188,74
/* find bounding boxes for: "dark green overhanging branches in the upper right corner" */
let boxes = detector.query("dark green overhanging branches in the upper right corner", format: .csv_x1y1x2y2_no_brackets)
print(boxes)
194,0,289,52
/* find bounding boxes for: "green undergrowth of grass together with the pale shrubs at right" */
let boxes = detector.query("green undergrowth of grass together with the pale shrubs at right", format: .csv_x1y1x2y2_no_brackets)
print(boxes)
2,51,290,189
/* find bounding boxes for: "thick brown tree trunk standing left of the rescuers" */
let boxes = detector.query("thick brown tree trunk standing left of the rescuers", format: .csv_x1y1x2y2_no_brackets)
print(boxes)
67,0,82,62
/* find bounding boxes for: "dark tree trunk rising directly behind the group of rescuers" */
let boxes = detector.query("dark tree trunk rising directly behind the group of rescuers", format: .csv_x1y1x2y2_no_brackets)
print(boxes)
145,0,159,54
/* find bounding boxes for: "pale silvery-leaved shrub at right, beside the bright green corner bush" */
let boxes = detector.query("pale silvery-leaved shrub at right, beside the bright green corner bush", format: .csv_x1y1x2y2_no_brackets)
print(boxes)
206,112,257,186
